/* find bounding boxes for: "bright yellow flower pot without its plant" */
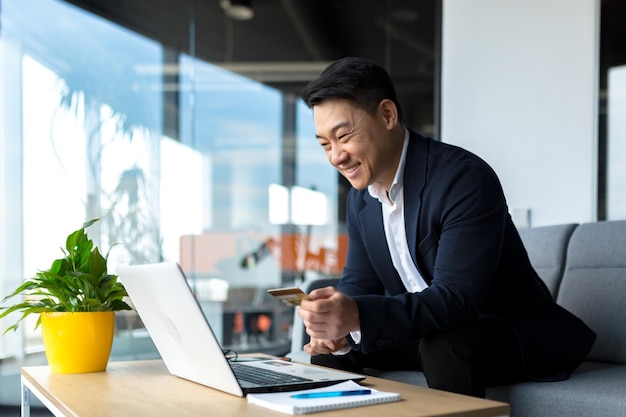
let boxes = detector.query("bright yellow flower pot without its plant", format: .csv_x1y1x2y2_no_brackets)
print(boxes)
41,311,115,374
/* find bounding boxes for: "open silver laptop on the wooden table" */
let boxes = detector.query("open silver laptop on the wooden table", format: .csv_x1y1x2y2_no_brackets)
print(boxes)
117,262,365,397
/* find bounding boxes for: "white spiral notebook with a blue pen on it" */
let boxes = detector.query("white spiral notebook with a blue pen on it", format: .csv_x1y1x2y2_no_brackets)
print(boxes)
248,381,401,415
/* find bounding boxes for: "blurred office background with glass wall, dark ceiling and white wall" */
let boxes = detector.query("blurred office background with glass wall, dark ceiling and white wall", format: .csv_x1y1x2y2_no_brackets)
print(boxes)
0,0,626,404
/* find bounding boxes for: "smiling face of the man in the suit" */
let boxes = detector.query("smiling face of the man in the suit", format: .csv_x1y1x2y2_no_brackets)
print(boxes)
313,99,397,190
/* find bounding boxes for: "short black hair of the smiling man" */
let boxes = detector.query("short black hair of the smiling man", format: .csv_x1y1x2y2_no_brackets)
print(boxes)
301,57,402,121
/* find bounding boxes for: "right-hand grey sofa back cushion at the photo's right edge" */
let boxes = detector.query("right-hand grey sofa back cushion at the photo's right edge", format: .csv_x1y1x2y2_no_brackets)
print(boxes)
557,221,626,364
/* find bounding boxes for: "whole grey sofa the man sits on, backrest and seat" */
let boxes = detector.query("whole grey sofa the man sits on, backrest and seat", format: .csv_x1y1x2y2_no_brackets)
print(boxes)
290,221,626,417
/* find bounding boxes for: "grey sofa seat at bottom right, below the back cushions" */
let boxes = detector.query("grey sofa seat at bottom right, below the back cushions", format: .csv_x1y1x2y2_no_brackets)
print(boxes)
487,362,626,417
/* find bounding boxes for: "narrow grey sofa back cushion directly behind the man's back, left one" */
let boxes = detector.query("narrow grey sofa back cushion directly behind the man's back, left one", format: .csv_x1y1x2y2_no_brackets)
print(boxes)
518,223,578,299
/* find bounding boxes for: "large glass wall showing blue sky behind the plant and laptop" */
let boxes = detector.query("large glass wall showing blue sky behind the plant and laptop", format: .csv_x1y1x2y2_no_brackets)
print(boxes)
0,0,352,374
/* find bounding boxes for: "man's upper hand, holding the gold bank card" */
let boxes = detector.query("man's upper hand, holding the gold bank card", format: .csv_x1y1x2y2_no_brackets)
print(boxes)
298,287,360,342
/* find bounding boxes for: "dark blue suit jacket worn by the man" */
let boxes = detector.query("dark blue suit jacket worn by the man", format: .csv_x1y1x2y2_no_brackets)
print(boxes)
338,132,595,380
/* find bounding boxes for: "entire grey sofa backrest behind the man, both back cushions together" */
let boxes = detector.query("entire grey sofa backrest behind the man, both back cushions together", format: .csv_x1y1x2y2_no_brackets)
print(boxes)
292,220,626,364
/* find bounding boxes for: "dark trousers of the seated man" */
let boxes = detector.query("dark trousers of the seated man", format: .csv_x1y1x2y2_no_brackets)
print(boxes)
311,320,525,398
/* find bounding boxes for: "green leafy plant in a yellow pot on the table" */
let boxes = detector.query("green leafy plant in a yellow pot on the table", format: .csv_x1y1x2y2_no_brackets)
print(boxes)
0,219,131,373
